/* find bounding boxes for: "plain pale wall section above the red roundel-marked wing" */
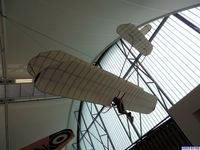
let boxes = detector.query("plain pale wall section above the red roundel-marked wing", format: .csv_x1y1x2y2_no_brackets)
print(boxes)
0,99,71,150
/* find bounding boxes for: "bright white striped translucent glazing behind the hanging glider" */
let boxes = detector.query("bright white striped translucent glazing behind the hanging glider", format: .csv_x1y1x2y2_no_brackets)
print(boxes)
77,7,200,149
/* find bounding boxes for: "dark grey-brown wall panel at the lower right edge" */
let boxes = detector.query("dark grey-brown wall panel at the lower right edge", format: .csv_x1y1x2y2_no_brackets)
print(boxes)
169,85,200,145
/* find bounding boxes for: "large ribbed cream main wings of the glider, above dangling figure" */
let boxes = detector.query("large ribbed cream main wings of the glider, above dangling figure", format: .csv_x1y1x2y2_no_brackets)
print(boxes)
28,51,156,113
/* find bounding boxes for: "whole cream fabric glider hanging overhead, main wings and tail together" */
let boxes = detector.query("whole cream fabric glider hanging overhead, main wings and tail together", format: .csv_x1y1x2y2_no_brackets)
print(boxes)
23,24,157,150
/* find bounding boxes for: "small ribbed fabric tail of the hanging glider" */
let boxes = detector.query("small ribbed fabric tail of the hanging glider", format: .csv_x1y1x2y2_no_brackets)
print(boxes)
117,23,153,56
